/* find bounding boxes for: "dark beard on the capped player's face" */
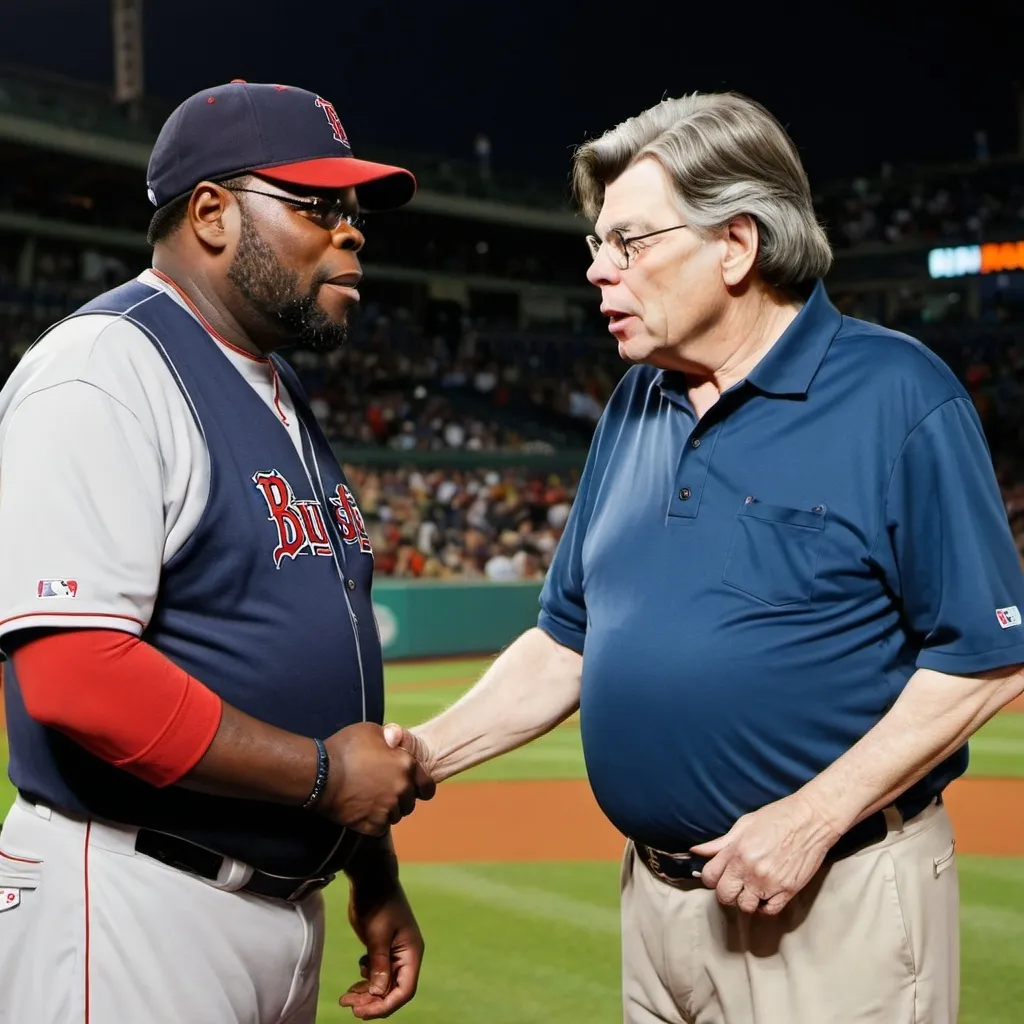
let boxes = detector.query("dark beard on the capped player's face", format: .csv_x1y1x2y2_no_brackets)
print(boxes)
227,209,348,352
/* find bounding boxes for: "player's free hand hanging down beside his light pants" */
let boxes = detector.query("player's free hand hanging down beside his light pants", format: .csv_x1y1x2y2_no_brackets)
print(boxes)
339,881,423,1020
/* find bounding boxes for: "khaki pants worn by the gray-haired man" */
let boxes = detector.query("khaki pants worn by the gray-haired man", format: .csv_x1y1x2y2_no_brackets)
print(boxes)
621,804,959,1024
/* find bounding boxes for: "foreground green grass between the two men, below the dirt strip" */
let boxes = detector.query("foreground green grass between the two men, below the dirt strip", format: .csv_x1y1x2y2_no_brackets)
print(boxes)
317,863,622,1024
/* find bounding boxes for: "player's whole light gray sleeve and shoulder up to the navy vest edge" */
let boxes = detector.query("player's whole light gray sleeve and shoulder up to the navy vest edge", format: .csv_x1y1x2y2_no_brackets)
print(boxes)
0,316,209,638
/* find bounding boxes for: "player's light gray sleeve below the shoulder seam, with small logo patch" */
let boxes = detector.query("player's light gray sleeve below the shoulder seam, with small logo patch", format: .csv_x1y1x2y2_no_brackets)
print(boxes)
0,381,164,635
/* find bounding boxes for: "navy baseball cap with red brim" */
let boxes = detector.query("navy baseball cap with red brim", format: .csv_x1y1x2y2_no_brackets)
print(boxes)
146,79,416,210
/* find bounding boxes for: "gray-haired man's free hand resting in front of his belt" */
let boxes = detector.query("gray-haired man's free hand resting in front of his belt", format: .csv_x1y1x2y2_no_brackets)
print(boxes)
690,793,840,914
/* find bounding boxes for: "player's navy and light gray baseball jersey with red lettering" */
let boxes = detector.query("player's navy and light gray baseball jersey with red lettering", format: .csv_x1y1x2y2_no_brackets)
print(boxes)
0,272,383,876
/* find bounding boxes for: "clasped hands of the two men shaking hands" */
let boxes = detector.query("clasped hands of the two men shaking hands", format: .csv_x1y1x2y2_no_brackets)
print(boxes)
315,722,436,836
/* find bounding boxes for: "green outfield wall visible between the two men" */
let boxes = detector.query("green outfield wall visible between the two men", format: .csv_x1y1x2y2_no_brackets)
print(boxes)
374,577,541,660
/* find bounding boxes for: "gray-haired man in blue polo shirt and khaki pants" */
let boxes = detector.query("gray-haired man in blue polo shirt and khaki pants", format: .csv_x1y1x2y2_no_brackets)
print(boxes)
385,94,1024,1024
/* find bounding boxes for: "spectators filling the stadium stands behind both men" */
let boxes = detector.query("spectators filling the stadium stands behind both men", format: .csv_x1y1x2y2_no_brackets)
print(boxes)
0,154,1024,580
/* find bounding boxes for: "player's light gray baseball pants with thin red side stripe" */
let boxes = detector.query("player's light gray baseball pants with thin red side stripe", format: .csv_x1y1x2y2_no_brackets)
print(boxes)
0,797,324,1024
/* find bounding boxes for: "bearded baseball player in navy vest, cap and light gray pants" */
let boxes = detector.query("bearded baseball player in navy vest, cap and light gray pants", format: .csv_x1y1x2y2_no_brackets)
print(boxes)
0,82,433,1024
